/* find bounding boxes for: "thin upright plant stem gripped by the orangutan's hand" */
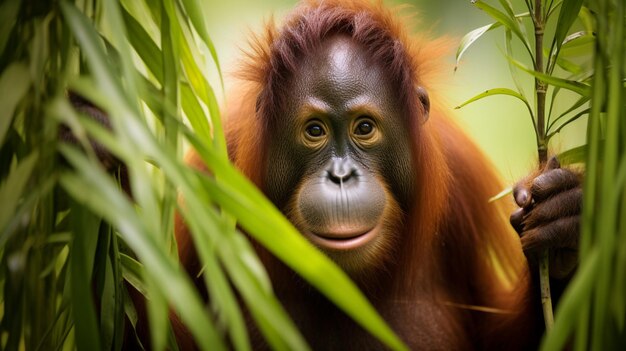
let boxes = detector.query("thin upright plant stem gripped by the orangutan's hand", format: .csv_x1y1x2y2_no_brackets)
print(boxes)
533,0,554,332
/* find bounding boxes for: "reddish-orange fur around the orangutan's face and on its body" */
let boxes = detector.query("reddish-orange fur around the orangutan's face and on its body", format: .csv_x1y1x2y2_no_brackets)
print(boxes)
177,0,532,349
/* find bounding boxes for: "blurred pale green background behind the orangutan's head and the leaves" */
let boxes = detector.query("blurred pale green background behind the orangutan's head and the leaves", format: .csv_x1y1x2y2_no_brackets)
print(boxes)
201,0,587,186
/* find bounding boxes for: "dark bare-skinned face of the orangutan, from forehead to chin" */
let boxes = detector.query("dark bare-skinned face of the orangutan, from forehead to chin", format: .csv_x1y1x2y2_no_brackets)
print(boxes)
264,36,414,272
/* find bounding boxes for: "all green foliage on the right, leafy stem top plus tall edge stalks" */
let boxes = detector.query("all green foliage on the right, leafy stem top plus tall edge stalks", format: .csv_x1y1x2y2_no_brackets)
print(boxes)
457,0,626,350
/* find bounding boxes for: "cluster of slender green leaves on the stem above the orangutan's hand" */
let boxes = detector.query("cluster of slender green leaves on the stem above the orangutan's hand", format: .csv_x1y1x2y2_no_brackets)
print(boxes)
455,0,596,149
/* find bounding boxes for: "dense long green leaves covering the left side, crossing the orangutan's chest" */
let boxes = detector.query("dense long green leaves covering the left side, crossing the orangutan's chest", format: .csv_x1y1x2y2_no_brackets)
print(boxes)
0,0,403,350
